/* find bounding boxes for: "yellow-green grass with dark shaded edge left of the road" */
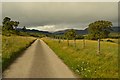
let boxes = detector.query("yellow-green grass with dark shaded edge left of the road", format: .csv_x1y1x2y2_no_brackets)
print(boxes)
2,36,35,71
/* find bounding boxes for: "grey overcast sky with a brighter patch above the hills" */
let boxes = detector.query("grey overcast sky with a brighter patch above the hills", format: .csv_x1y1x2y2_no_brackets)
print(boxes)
2,2,118,31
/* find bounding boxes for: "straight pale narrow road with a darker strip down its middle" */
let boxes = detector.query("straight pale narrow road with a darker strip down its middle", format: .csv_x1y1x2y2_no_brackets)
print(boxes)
3,39,76,78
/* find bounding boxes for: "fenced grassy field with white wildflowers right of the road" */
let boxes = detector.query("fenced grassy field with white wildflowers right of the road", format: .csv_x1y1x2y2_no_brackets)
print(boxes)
42,38,118,78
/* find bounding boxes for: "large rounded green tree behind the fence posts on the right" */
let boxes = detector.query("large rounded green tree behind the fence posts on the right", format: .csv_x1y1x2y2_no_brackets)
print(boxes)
88,20,112,39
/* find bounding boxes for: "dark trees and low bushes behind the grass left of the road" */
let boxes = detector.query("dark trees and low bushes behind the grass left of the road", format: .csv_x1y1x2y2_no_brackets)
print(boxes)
2,17,45,37
